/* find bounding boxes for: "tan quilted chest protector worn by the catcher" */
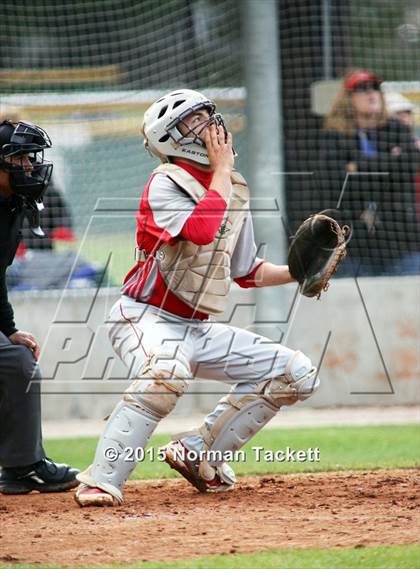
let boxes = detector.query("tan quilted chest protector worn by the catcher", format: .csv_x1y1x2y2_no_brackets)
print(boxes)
154,164,249,314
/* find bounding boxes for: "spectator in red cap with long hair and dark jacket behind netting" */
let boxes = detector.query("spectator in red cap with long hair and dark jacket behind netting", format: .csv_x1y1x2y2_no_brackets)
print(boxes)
320,71,419,275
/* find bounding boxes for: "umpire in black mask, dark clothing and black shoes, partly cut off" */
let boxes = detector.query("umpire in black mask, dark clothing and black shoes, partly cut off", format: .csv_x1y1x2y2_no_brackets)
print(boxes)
0,121,79,494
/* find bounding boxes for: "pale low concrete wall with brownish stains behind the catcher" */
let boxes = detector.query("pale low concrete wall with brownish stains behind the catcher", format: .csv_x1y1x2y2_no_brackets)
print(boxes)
11,277,420,419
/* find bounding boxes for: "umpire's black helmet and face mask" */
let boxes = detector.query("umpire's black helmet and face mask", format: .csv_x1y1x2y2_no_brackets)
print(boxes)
0,121,53,201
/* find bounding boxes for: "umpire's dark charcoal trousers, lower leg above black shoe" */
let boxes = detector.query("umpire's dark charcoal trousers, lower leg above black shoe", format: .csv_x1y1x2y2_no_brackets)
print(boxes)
0,332,45,467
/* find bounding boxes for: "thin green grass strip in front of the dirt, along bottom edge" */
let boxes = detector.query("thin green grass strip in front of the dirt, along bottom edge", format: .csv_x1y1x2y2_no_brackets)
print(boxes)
9,545,420,569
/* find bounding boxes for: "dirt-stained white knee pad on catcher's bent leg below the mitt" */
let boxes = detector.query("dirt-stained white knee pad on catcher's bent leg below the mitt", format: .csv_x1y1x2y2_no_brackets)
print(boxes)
264,351,319,408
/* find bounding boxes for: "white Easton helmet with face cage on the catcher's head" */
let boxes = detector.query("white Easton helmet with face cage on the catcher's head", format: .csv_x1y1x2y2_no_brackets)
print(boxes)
143,89,226,164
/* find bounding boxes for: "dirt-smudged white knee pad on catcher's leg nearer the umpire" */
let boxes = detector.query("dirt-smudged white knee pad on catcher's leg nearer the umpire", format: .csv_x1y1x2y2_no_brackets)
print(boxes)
124,347,191,420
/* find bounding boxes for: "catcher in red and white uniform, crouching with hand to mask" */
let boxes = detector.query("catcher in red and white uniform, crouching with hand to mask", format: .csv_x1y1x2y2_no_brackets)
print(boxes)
75,89,344,506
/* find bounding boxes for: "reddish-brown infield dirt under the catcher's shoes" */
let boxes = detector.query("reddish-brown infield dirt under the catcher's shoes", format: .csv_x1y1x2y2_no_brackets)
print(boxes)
0,469,420,565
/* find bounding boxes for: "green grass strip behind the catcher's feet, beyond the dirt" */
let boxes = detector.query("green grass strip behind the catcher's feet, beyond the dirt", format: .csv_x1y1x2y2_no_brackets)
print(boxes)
46,425,420,479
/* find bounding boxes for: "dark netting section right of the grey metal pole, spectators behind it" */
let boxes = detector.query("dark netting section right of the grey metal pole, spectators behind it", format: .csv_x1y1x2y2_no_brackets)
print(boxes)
280,0,420,274
